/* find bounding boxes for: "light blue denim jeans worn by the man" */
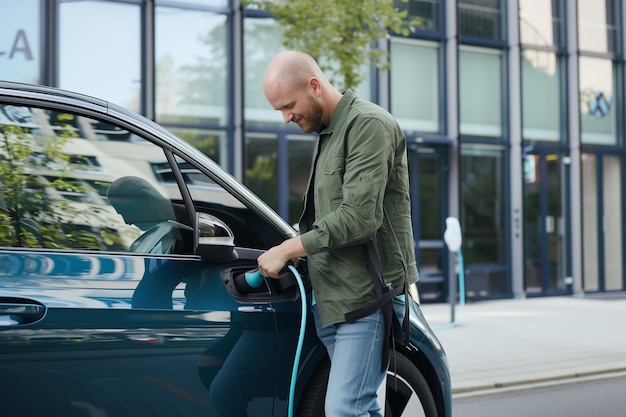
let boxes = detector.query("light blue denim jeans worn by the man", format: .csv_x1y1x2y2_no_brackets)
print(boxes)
313,306,387,417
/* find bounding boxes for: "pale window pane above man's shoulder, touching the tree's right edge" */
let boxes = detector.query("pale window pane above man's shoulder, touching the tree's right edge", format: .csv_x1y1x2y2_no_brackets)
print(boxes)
391,38,441,133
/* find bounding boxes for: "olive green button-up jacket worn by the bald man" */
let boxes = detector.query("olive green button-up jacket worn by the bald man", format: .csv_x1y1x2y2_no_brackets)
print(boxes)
299,90,418,326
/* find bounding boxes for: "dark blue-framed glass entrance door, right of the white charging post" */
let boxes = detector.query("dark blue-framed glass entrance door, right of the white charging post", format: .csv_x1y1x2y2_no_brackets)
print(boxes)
524,151,571,295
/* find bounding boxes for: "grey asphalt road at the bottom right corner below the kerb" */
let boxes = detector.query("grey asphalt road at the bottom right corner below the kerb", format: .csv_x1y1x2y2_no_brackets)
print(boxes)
452,373,626,417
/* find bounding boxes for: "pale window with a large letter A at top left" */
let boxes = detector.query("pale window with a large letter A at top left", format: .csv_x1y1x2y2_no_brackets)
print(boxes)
0,0,41,84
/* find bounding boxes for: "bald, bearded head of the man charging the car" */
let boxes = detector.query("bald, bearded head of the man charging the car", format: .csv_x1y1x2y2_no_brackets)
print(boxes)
263,51,342,133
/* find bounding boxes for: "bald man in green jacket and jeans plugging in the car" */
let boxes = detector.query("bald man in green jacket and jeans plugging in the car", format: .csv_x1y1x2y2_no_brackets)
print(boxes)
258,51,418,417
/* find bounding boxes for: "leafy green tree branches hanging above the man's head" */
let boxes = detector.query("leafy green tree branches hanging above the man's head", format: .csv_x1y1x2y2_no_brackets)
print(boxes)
244,0,422,89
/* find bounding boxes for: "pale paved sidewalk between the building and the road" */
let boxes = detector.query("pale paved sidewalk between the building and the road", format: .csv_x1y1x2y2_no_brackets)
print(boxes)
421,293,626,394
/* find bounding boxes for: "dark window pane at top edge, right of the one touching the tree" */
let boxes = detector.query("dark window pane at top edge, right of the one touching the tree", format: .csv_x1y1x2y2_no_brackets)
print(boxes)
458,0,502,40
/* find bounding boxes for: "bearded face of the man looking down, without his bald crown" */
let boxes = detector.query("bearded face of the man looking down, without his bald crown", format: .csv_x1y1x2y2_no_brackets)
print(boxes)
267,81,323,133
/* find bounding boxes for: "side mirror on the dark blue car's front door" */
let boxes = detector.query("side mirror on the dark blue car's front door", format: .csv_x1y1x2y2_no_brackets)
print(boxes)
196,213,238,263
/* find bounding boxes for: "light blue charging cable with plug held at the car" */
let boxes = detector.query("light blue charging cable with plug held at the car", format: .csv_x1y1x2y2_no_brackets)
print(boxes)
235,265,307,417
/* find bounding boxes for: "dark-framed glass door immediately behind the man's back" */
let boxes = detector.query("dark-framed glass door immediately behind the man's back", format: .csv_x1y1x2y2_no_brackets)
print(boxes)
409,146,448,301
